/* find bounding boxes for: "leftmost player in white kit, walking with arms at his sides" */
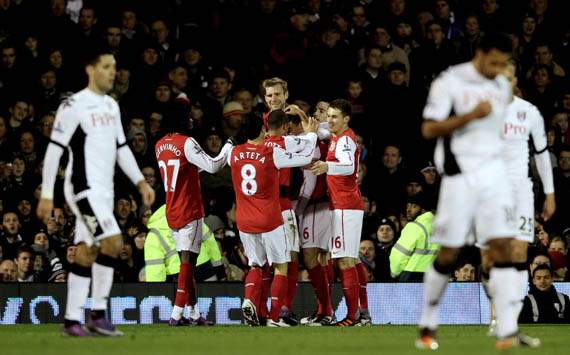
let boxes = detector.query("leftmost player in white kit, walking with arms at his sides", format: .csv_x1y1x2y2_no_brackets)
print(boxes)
37,49,154,336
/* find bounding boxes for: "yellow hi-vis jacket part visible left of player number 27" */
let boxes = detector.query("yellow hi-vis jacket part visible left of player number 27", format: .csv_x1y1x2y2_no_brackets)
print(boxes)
144,205,180,282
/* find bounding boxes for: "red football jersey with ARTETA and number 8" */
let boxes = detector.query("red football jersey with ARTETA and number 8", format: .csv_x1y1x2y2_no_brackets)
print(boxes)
230,143,283,233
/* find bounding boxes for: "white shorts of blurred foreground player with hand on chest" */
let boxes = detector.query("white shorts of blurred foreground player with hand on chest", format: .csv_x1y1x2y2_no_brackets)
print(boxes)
432,160,517,248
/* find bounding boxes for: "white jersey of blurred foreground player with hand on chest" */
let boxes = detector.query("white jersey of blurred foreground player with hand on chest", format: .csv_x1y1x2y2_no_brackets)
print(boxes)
423,62,511,175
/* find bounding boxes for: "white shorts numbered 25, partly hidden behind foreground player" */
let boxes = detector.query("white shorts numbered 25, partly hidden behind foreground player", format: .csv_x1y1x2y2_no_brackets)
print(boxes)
513,179,534,243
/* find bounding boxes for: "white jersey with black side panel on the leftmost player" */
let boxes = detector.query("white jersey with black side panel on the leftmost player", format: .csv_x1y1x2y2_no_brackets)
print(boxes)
51,89,127,196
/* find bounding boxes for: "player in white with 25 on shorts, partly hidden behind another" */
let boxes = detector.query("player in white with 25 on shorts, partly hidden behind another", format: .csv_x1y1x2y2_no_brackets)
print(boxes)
481,62,556,341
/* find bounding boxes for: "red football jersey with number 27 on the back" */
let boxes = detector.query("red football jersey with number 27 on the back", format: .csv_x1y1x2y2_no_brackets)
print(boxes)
155,133,204,228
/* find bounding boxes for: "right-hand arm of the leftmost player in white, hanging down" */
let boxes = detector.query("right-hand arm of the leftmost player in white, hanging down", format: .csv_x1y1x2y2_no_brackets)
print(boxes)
116,107,155,206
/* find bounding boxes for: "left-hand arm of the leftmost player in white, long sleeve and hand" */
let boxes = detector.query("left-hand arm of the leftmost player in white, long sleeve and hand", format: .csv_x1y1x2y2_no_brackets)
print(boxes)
37,98,79,220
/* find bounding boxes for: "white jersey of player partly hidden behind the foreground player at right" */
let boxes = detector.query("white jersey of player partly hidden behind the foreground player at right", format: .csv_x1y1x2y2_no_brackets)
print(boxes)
502,96,547,180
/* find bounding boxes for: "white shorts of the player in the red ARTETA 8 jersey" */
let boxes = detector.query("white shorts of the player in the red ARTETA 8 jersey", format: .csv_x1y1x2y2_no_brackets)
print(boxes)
239,225,291,266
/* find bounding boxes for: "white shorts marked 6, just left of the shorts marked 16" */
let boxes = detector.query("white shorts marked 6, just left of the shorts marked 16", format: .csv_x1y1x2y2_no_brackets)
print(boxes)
301,202,332,251
